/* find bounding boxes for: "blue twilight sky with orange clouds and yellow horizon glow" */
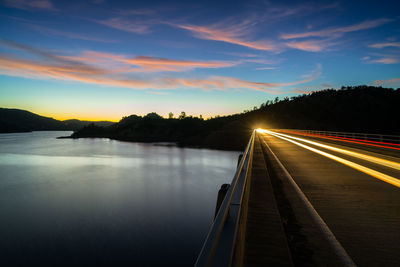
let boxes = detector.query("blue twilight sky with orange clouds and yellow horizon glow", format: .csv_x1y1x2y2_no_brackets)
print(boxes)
0,0,400,121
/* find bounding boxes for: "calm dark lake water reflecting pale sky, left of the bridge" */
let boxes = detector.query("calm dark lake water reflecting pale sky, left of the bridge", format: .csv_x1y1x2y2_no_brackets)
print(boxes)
0,132,239,266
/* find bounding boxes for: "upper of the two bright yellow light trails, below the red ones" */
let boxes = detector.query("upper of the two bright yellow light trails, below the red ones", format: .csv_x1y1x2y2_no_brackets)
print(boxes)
266,132,400,170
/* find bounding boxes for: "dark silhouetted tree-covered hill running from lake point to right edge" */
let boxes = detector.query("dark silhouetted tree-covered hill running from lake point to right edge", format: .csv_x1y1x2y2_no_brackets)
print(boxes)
72,86,400,150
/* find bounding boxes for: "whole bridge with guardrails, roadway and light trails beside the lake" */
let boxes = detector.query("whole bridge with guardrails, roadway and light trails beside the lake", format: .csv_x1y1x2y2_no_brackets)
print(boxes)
195,129,400,266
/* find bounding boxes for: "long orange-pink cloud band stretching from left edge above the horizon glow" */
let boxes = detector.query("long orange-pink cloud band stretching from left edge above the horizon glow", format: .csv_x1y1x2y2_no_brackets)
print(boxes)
0,56,319,93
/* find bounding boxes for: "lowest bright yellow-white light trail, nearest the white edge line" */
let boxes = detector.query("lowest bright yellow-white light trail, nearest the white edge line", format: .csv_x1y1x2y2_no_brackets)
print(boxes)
257,129,400,187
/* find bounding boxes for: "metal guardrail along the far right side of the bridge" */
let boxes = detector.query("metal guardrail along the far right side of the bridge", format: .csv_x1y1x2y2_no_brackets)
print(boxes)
273,129,400,144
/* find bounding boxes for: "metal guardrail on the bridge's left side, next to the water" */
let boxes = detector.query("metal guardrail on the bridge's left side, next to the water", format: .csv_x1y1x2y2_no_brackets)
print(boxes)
195,131,255,267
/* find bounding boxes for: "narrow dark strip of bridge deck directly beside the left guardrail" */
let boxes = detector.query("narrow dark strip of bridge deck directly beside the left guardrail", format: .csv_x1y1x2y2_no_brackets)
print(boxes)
244,137,292,266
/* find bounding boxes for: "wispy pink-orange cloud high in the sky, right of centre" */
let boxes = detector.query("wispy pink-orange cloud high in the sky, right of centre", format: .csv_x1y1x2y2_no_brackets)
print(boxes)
170,20,280,51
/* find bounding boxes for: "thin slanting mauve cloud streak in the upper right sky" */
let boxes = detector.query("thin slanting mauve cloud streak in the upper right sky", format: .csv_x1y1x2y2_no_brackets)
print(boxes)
280,18,392,40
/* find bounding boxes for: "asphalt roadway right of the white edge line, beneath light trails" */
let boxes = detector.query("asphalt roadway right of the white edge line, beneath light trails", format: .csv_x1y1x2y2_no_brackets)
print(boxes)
263,133,400,266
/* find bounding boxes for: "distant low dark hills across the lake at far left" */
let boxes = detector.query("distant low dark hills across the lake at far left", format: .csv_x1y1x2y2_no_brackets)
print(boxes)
0,108,113,133
